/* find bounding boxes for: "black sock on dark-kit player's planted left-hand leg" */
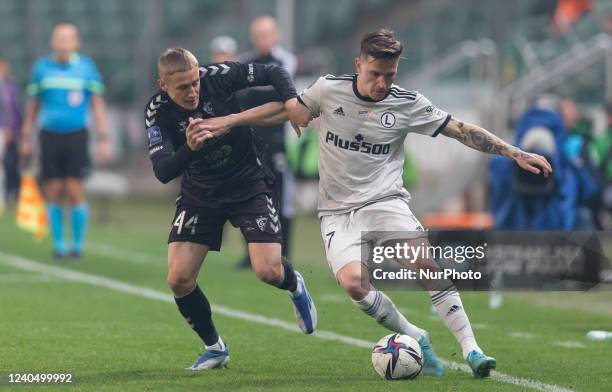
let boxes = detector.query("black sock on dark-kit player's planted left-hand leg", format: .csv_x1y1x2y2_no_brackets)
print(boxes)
174,285,219,346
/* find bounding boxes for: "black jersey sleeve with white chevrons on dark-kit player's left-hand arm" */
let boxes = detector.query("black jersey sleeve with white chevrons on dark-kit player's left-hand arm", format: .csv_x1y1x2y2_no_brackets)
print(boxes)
145,95,196,184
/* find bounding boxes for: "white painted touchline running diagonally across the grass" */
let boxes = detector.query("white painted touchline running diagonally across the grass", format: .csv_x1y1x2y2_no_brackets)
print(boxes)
0,252,573,392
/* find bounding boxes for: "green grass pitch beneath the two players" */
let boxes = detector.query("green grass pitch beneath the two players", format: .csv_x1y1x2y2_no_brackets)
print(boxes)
0,200,612,391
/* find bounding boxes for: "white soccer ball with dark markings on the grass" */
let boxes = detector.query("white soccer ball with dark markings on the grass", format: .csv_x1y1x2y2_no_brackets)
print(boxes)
372,333,423,380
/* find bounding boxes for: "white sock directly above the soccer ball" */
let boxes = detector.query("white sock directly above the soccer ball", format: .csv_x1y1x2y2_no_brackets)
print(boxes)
353,291,425,340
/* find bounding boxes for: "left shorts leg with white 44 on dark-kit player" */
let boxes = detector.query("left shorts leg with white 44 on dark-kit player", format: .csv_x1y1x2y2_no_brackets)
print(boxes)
168,203,226,251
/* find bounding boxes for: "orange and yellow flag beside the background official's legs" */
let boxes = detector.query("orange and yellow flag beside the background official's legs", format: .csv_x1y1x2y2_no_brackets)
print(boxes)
17,173,49,241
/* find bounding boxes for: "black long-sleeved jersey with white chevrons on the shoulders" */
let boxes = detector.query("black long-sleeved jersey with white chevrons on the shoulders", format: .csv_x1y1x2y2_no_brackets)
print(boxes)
145,62,297,206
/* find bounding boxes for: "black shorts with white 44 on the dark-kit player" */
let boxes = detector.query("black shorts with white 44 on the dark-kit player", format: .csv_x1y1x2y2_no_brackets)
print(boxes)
168,185,282,251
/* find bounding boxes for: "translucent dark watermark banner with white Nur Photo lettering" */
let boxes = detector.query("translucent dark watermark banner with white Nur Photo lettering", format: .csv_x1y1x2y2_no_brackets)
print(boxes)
361,230,612,290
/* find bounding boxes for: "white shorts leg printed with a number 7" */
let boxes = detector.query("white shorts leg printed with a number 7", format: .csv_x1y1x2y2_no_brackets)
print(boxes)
321,213,363,276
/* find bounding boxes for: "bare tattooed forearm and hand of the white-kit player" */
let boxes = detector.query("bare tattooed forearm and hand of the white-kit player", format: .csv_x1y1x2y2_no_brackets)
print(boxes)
442,117,552,177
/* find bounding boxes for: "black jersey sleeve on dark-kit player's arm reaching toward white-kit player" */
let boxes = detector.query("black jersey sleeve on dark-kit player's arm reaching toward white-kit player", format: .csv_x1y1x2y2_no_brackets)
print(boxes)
200,61,297,102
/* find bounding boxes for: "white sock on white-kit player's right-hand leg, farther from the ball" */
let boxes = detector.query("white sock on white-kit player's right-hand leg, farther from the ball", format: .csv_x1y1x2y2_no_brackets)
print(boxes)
429,285,482,358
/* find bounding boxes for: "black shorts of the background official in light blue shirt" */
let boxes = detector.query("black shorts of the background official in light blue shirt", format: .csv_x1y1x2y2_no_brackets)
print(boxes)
40,129,91,180
